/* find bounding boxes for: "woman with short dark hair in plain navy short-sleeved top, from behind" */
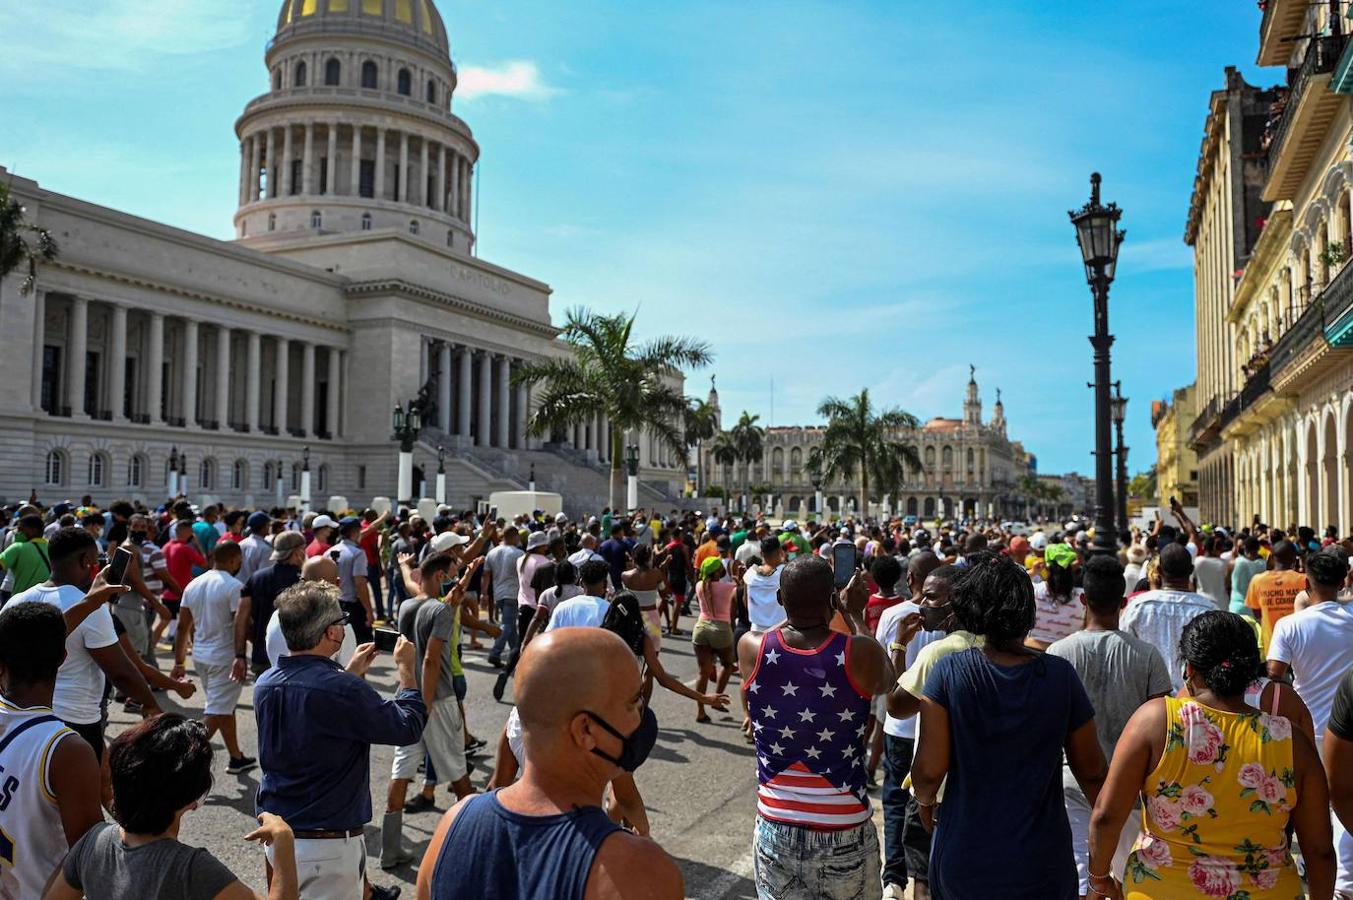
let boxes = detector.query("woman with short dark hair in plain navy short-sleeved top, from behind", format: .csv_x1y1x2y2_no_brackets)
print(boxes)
912,555,1107,900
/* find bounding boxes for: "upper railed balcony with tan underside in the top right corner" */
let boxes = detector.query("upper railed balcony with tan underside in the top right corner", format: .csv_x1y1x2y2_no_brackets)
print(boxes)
1264,34,1348,202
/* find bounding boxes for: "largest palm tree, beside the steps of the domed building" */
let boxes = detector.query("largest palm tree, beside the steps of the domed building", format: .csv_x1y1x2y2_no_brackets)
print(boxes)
513,307,713,508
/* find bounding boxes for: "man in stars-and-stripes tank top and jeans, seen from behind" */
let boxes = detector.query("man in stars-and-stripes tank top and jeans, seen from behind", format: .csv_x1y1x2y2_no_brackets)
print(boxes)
737,556,894,900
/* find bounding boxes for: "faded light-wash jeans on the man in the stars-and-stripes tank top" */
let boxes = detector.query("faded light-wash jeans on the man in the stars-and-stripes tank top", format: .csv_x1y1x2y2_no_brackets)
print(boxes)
752,816,884,900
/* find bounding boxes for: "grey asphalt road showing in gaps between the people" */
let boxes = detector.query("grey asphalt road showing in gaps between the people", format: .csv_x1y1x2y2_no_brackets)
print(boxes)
101,618,756,900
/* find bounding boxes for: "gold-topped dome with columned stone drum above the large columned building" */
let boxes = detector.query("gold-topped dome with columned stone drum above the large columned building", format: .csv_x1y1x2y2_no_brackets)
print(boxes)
235,0,479,252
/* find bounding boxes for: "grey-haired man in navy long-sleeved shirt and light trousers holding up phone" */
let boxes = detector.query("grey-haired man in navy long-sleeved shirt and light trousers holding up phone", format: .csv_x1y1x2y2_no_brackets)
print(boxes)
254,582,428,900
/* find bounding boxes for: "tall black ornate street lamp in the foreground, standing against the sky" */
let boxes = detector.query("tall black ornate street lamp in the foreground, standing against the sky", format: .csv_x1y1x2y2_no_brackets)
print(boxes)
1068,172,1127,554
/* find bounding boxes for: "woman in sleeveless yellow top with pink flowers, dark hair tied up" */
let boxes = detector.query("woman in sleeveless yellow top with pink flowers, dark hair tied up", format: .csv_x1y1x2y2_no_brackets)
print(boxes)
1088,610,1334,900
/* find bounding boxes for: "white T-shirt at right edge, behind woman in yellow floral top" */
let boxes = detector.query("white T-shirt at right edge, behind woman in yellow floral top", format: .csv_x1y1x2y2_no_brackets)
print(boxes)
1269,600,1353,747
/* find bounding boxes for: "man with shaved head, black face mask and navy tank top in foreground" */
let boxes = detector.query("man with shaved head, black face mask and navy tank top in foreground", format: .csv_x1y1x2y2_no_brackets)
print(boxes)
418,628,685,900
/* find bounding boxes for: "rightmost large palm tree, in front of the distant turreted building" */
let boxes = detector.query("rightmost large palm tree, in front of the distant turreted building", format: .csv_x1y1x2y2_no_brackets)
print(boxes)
817,387,921,514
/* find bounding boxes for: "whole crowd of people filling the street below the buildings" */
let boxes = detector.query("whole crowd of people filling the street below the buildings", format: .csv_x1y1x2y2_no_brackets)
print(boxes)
0,498,1353,900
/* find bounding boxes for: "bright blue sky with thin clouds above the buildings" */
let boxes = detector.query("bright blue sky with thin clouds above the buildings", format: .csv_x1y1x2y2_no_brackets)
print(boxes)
0,0,1266,472
